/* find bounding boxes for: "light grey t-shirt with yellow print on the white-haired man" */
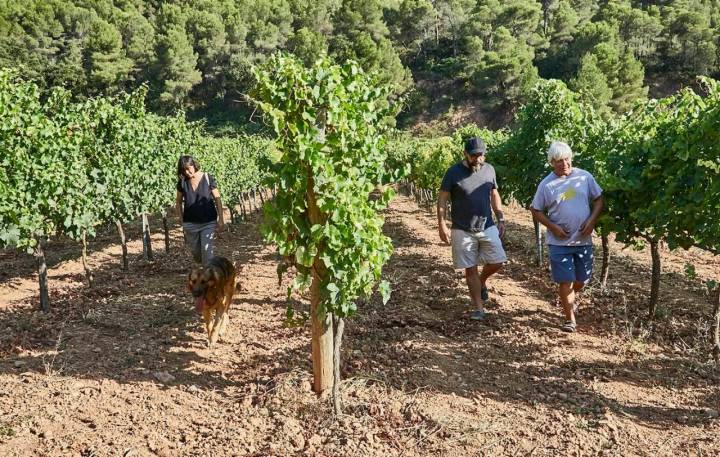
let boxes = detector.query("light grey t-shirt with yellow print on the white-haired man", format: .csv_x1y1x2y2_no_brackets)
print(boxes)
530,168,602,246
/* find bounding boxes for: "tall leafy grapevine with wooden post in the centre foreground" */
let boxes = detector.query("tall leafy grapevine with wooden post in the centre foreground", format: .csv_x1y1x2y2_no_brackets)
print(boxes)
253,55,399,414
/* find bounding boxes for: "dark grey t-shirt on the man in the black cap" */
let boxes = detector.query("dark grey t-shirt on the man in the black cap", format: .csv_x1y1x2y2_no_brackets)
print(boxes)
440,162,497,232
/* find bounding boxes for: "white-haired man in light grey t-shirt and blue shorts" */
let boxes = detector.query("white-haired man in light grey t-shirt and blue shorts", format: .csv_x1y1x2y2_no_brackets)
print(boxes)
530,141,603,332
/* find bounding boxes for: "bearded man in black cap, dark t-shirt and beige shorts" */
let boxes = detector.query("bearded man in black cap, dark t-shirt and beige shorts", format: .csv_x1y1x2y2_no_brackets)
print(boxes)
437,137,507,320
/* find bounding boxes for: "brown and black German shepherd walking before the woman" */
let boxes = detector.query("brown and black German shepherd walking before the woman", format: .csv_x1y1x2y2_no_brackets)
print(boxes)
187,257,236,347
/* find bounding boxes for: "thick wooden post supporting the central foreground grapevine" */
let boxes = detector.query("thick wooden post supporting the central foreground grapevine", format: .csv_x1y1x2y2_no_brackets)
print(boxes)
306,177,333,394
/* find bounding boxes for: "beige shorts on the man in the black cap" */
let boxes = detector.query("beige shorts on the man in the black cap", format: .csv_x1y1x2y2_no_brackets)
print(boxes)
451,225,507,268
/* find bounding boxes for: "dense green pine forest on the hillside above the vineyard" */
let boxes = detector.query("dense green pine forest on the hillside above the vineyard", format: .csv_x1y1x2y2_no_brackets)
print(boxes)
0,0,720,128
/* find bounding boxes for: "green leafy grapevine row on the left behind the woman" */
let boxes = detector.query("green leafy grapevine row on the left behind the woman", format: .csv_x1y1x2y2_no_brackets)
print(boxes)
0,70,272,309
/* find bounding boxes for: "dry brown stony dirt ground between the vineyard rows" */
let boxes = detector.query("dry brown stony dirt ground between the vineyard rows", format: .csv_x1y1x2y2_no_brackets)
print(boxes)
0,191,720,457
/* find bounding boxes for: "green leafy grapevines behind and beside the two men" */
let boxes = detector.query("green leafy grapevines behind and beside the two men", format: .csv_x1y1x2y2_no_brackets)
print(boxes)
389,79,720,317
